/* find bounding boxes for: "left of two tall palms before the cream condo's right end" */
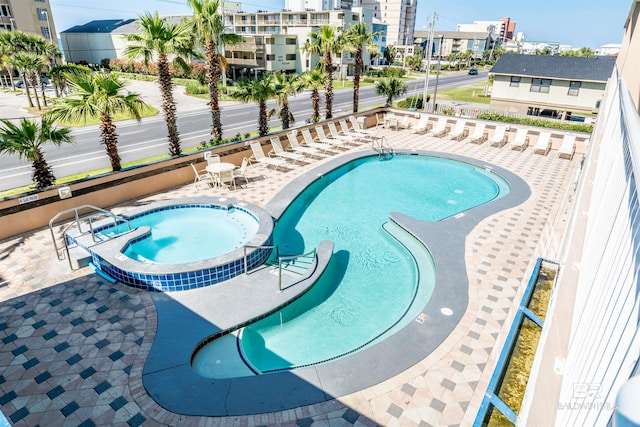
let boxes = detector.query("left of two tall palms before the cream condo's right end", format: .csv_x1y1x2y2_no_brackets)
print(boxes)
303,25,345,119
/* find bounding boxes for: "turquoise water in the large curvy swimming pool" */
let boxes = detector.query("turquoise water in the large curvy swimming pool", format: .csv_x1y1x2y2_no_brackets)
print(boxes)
194,155,508,375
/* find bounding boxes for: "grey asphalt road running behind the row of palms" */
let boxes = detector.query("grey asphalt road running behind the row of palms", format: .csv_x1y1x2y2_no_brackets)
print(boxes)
0,72,487,190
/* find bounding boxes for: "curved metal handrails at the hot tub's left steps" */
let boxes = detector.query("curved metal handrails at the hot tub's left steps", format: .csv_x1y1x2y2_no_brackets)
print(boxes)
49,205,131,270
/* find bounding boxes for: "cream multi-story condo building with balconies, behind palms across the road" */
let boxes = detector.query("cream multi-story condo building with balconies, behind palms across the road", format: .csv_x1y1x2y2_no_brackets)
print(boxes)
225,7,373,79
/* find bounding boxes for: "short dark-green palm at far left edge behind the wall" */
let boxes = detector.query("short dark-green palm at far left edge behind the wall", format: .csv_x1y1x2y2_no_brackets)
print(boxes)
0,117,72,190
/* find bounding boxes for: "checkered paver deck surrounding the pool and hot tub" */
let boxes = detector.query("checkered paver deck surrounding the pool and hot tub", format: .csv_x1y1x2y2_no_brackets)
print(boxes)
0,125,579,426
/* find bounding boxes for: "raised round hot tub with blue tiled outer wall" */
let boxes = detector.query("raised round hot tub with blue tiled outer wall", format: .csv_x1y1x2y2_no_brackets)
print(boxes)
67,197,273,291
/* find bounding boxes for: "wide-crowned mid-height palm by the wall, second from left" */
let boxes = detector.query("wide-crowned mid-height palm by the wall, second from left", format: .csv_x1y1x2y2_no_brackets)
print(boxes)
49,73,147,171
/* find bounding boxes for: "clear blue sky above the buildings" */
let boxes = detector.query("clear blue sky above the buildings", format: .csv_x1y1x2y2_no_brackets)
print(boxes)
51,0,632,48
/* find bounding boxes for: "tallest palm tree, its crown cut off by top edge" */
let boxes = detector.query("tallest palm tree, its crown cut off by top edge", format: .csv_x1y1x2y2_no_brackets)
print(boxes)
188,0,242,141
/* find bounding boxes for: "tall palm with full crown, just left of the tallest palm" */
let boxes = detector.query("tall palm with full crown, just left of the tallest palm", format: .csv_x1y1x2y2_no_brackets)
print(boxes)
124,12,195,156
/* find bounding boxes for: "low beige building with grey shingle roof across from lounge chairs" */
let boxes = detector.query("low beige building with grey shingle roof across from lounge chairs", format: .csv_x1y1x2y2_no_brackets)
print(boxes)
491,54,616,117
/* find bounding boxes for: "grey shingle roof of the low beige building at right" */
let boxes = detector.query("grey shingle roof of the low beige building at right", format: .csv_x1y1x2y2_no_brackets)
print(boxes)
490,54,616,82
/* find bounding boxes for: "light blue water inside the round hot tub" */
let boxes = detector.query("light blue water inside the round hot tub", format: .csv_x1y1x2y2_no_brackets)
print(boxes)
103,206,259,264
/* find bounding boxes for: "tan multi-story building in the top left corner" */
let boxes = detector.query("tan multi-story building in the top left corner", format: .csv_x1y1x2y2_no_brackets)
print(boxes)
0,0,57,44
